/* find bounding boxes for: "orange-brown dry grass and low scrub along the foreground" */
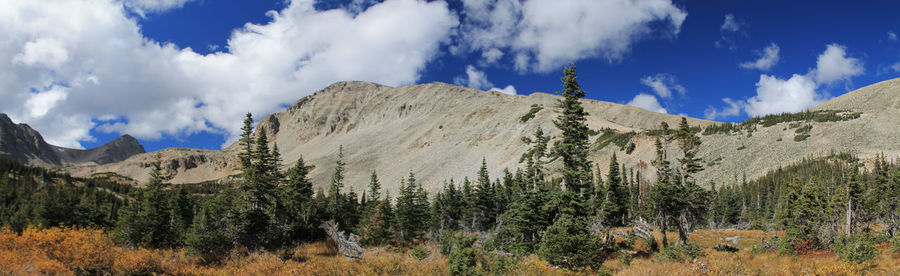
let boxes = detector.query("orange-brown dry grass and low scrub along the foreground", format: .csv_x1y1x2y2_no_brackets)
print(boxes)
0,228,900,275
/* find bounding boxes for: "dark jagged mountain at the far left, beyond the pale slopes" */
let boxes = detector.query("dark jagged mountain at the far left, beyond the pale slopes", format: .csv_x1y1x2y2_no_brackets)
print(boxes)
0,113,145,166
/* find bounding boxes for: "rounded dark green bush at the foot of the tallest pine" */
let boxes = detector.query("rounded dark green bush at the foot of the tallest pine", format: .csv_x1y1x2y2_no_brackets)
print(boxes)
537,214,606,269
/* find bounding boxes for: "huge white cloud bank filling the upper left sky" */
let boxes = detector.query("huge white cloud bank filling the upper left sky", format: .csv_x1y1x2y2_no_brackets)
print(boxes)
0,0,459,147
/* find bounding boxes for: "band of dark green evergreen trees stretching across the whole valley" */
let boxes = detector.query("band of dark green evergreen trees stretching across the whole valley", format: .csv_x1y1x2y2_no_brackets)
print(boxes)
0,66,900,268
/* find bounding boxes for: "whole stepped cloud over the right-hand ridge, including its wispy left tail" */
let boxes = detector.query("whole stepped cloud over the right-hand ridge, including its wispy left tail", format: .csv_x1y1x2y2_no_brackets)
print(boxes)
705,44,863,119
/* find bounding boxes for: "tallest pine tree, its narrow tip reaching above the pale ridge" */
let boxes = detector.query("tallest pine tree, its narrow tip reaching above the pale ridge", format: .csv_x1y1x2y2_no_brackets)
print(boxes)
553,64,591,201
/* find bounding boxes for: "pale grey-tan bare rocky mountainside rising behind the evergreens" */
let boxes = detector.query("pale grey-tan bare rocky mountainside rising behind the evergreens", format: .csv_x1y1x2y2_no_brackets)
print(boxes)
67,79,900,191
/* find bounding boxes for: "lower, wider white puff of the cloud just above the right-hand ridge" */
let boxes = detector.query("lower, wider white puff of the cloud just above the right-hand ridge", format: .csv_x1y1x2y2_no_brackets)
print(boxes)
744,74,825,116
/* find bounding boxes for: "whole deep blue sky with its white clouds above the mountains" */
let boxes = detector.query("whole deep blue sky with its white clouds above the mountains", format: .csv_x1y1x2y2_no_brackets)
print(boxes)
0,0,900,150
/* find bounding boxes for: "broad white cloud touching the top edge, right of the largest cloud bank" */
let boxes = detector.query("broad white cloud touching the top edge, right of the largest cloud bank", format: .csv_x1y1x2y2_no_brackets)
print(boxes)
461,0,687,72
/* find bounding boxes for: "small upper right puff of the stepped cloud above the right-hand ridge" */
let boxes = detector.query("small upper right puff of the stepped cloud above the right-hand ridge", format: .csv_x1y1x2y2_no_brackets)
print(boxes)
810,43,864,84
